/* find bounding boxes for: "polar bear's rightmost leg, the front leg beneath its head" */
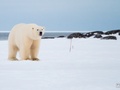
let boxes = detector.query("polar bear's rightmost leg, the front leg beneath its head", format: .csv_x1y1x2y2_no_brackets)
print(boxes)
30,40,40,60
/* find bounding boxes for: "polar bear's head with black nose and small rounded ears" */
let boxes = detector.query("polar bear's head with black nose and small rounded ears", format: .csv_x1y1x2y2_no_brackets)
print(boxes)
30,24,45,40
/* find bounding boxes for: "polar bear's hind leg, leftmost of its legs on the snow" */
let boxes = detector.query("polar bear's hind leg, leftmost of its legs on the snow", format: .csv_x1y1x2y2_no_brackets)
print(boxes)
8,46,18,60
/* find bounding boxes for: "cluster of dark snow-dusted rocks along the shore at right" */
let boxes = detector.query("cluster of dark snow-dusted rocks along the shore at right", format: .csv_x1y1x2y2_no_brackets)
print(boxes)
67,30,120,40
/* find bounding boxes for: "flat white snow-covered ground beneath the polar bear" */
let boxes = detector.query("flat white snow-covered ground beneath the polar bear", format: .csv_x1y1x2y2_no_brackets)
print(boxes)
0,36,120,90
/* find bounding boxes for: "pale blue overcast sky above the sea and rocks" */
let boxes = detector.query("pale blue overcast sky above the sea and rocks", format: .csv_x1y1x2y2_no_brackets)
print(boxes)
0,0,120,31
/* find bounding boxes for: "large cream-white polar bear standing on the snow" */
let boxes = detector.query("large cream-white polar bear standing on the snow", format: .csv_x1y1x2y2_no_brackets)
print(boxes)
8,24,44,60
